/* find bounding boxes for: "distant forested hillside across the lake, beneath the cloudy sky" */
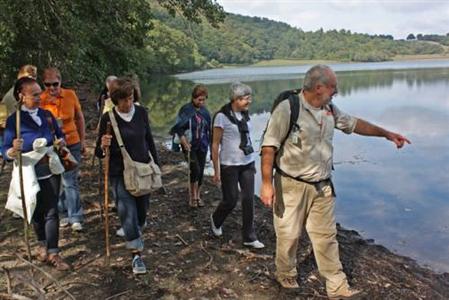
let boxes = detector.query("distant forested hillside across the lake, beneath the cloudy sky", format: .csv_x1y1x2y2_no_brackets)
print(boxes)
154,10,444,65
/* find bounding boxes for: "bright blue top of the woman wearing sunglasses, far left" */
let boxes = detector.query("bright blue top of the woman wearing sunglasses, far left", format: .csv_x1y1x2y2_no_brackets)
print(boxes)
2,108,64,160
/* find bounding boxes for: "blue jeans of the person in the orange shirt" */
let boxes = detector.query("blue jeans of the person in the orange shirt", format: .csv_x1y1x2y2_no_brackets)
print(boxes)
58,143,83,224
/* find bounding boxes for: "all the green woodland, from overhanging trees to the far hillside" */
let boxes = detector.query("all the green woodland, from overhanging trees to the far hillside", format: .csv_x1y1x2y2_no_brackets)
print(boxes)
0,0,449,91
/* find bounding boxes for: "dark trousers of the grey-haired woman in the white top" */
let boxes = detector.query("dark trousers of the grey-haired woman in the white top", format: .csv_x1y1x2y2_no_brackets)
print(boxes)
212,162,257,242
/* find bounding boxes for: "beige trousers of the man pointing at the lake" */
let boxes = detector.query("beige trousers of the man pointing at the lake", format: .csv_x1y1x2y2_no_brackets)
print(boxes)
273,174,348,294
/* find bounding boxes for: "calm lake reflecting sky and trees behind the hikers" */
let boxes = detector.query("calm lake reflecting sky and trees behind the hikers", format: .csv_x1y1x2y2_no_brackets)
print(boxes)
142,60,449,272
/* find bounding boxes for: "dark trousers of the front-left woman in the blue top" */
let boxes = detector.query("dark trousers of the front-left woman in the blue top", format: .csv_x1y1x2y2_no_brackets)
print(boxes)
33,175,61,253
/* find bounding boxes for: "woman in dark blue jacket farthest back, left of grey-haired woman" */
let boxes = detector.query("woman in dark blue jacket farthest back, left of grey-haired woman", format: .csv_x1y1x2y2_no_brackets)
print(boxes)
170,84,211,207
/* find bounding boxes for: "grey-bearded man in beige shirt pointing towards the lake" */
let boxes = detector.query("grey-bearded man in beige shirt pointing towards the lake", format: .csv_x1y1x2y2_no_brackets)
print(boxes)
260,65,410,299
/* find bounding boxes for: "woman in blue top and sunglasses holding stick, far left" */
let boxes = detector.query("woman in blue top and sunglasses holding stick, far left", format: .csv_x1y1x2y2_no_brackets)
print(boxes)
2,77,70,271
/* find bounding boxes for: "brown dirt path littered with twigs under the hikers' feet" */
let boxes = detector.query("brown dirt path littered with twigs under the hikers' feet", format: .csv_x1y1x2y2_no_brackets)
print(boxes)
0,97,449,299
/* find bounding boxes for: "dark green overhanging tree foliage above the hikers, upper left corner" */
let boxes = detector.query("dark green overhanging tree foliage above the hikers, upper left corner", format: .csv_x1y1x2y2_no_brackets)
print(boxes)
0,0,224,89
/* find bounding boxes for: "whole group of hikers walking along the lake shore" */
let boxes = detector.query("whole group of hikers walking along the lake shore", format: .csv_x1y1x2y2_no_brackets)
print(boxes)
2,65,410,299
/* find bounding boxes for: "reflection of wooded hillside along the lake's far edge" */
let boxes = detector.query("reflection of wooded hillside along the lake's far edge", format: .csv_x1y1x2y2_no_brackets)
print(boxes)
142,68,449,132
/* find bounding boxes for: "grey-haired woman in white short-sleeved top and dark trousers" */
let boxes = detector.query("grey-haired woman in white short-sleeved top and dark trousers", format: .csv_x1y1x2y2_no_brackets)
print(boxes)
210,82,264,249
